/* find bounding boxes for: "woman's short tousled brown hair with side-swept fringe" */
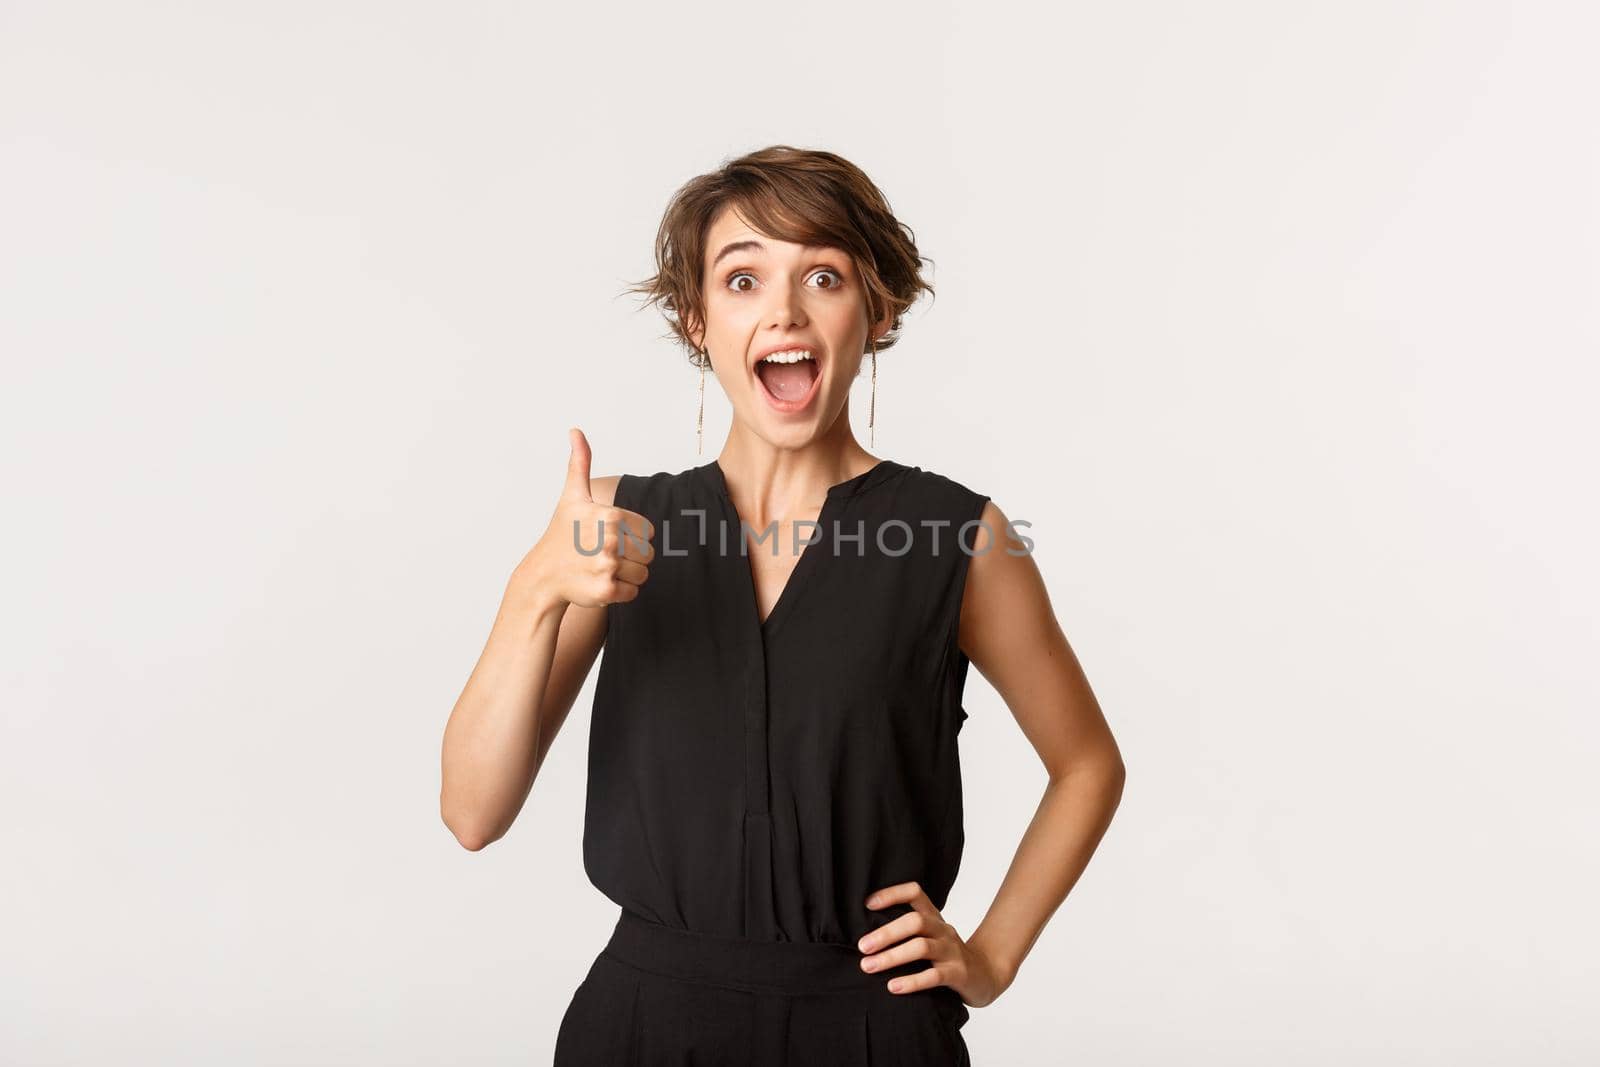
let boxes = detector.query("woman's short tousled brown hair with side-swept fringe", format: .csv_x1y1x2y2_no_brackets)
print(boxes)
624,144,933,365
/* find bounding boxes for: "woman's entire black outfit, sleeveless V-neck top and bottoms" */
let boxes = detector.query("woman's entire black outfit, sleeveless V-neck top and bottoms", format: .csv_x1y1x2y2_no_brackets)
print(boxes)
555,459,1000,1067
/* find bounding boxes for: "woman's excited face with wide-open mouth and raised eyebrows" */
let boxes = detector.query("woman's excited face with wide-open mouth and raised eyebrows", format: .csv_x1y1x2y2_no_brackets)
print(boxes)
696,208,890,448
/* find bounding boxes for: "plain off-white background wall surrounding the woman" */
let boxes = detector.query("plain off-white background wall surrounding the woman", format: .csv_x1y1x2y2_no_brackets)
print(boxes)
0,2,1600,1067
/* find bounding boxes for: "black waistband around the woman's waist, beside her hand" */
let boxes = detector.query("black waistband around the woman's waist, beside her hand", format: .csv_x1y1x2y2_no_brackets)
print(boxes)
602,909,928,997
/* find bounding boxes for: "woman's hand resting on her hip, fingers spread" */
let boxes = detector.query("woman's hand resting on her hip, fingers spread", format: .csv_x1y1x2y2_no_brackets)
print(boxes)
856,881,1010,1008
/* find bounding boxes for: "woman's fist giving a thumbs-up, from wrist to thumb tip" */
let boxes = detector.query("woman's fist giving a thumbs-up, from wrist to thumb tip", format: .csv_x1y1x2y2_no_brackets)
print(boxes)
525,427,656,608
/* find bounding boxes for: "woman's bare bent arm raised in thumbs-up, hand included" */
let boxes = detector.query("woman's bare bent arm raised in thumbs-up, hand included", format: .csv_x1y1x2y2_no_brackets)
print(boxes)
438,428,653,851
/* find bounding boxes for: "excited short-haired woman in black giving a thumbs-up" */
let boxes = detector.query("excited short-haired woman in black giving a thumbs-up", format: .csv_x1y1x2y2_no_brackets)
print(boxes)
440,146,1123,1067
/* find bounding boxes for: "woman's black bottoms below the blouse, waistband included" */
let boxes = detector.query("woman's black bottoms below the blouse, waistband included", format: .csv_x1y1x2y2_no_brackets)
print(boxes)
555,910,971,1067
